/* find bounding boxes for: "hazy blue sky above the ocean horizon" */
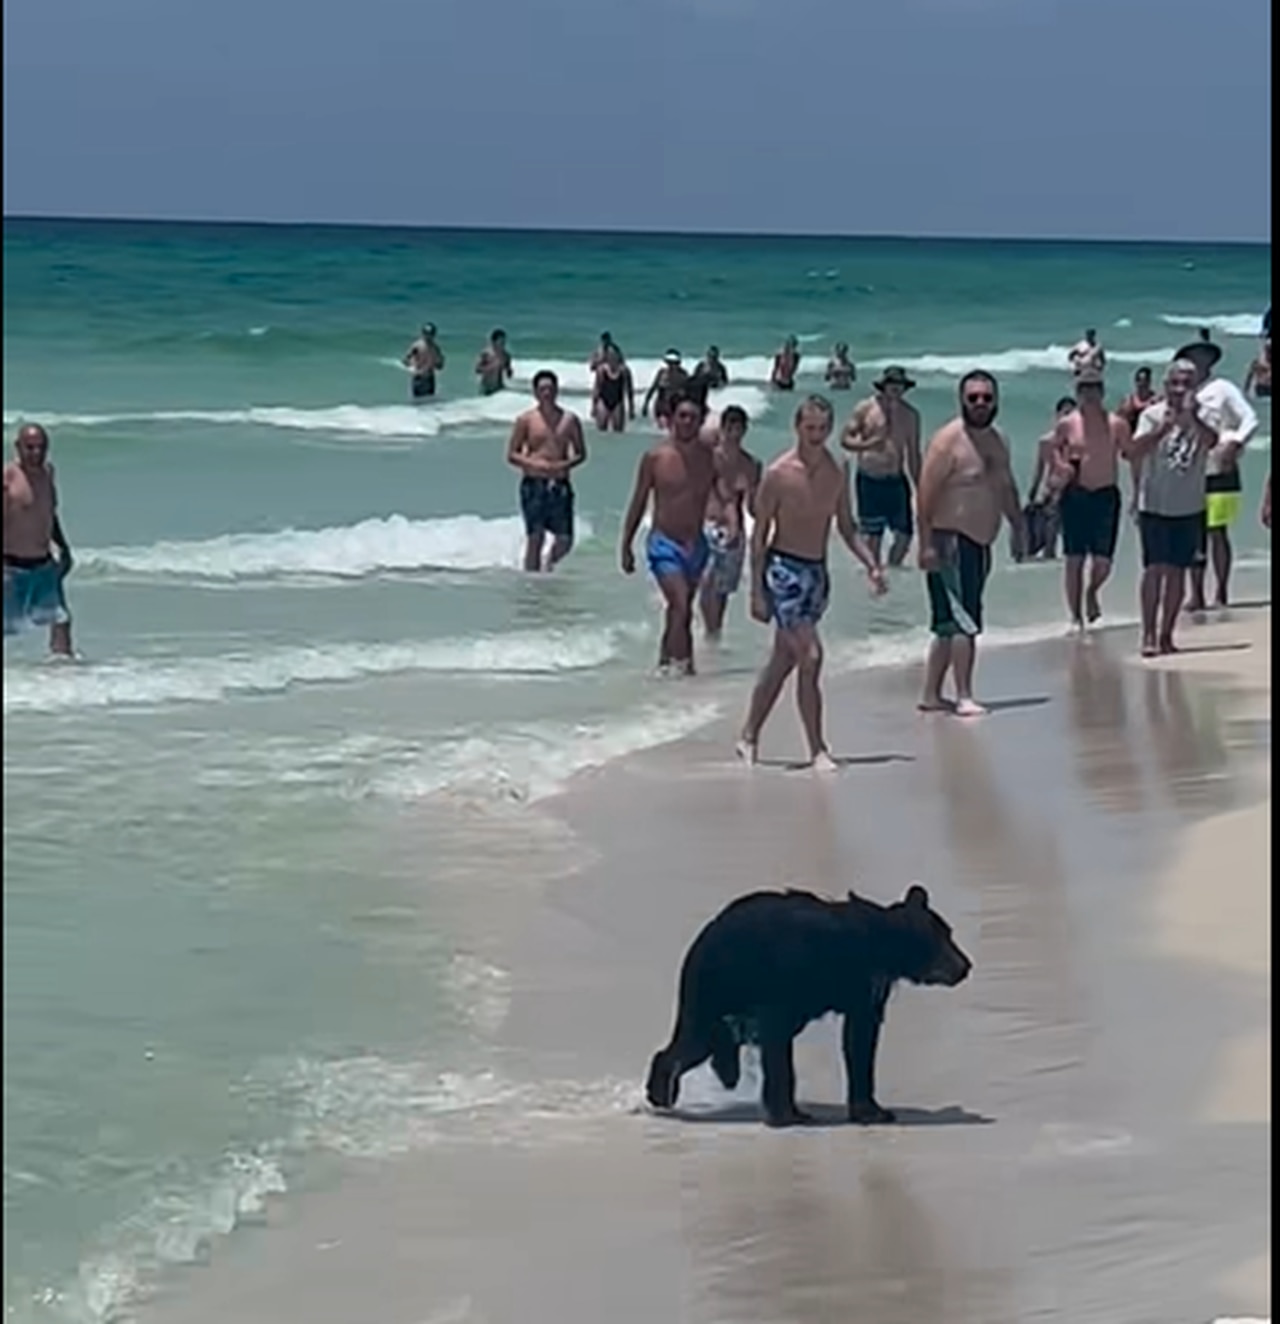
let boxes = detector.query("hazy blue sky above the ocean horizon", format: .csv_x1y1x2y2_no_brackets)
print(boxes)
4,0,1271,240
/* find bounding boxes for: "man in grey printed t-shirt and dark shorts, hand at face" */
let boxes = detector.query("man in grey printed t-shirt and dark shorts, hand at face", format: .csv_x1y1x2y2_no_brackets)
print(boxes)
1133,359,1218,657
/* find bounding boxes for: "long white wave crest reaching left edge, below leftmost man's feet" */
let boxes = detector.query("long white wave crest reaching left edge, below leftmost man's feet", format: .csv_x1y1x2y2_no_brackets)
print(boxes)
4,630,621,716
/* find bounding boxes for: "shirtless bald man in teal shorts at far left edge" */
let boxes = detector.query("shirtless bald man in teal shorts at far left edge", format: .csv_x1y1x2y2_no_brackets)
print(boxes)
4,422,73,658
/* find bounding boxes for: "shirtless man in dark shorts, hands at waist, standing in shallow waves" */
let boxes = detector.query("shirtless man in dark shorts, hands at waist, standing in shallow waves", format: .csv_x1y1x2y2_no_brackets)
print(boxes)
507,368,586,572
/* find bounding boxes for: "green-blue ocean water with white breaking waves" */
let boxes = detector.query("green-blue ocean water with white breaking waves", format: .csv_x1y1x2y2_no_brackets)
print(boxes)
4,221,1271,1324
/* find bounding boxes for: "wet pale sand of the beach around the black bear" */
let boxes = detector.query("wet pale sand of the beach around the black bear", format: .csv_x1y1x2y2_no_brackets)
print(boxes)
146,612,1271,1324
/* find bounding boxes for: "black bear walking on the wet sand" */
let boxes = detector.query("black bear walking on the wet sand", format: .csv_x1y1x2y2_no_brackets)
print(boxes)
645,883,973,1127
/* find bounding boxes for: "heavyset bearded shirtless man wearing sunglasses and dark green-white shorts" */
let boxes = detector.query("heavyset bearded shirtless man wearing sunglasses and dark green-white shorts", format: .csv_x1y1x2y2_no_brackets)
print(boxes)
916,371,1026,718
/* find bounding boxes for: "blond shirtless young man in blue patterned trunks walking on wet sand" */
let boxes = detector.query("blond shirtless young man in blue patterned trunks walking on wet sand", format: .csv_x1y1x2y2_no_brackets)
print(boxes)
737,396,884,772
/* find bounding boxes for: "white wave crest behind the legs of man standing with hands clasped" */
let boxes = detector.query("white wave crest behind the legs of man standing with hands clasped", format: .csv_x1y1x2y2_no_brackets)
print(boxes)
78,515,592,583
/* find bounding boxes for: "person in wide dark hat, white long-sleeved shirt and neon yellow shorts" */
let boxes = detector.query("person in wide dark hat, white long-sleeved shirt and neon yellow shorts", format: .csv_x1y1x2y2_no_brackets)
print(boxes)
1177,331,1257,612
